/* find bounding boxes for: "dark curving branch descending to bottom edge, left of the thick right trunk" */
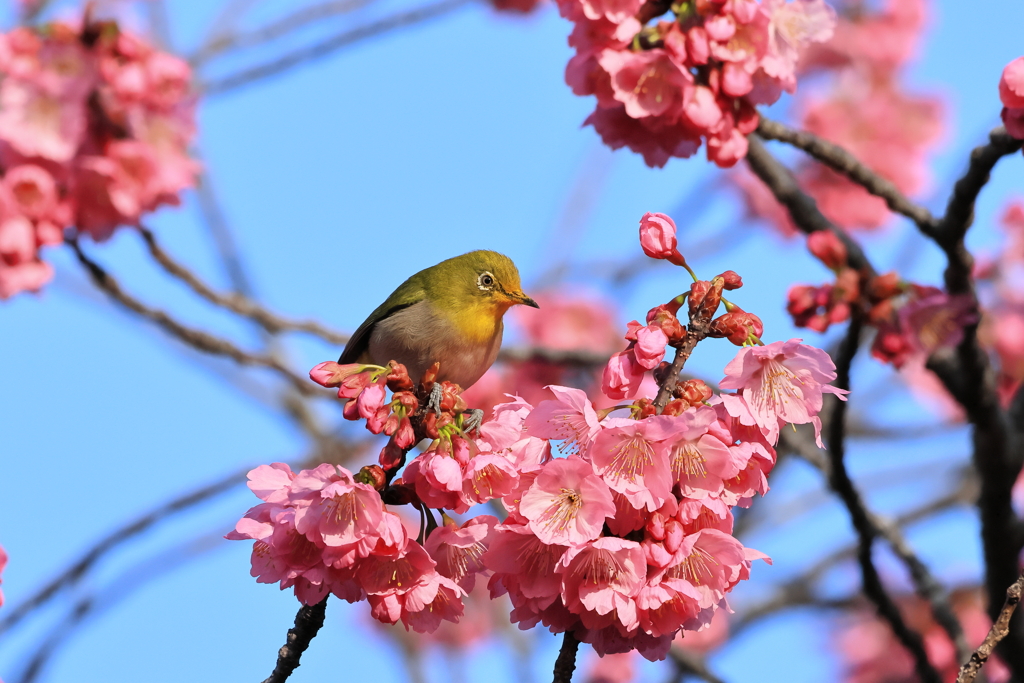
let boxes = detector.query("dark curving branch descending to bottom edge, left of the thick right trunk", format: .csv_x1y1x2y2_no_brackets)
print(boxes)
828,313,942,683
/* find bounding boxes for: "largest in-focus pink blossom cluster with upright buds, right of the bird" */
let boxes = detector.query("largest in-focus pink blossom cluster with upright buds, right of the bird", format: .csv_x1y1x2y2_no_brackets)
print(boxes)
483,214,844,658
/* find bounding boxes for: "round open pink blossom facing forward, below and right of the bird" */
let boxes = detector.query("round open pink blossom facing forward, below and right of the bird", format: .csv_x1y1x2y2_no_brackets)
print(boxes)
519,456,615,546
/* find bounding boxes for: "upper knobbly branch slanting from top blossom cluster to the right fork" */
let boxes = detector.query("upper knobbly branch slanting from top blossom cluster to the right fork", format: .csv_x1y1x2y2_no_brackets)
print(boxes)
758,117,939,237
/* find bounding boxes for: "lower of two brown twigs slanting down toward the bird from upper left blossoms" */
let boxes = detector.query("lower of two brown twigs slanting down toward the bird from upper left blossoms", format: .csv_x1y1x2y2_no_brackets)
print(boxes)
67,239,316,395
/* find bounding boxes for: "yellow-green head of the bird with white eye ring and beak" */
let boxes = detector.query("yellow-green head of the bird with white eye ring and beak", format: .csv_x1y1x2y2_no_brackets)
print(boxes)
428,251,540,317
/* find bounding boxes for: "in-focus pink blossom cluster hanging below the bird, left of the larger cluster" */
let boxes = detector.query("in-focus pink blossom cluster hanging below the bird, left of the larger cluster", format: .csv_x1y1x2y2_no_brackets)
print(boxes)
225,463,507,632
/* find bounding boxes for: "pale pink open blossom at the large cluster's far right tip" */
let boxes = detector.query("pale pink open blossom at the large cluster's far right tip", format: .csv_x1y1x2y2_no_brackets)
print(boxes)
719,339,847,445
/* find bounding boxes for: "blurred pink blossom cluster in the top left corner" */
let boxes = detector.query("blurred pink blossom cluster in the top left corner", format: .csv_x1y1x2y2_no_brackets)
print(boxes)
0,22,199,298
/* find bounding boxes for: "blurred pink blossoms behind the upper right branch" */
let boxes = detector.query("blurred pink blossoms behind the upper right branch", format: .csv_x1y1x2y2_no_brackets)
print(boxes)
735,0,943,234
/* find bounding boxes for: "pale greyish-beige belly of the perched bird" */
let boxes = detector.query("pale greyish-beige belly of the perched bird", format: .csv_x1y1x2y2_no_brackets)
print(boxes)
369,301,502,389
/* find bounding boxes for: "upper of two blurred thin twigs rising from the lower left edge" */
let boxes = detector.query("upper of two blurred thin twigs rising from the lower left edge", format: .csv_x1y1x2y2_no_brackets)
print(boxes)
0,467,252,634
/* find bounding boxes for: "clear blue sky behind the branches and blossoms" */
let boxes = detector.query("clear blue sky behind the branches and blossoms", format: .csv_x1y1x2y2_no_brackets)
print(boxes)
0,0,1024,683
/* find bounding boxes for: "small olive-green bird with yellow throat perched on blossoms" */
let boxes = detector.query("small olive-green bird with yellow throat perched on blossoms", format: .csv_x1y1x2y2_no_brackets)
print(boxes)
338,250,540,389
